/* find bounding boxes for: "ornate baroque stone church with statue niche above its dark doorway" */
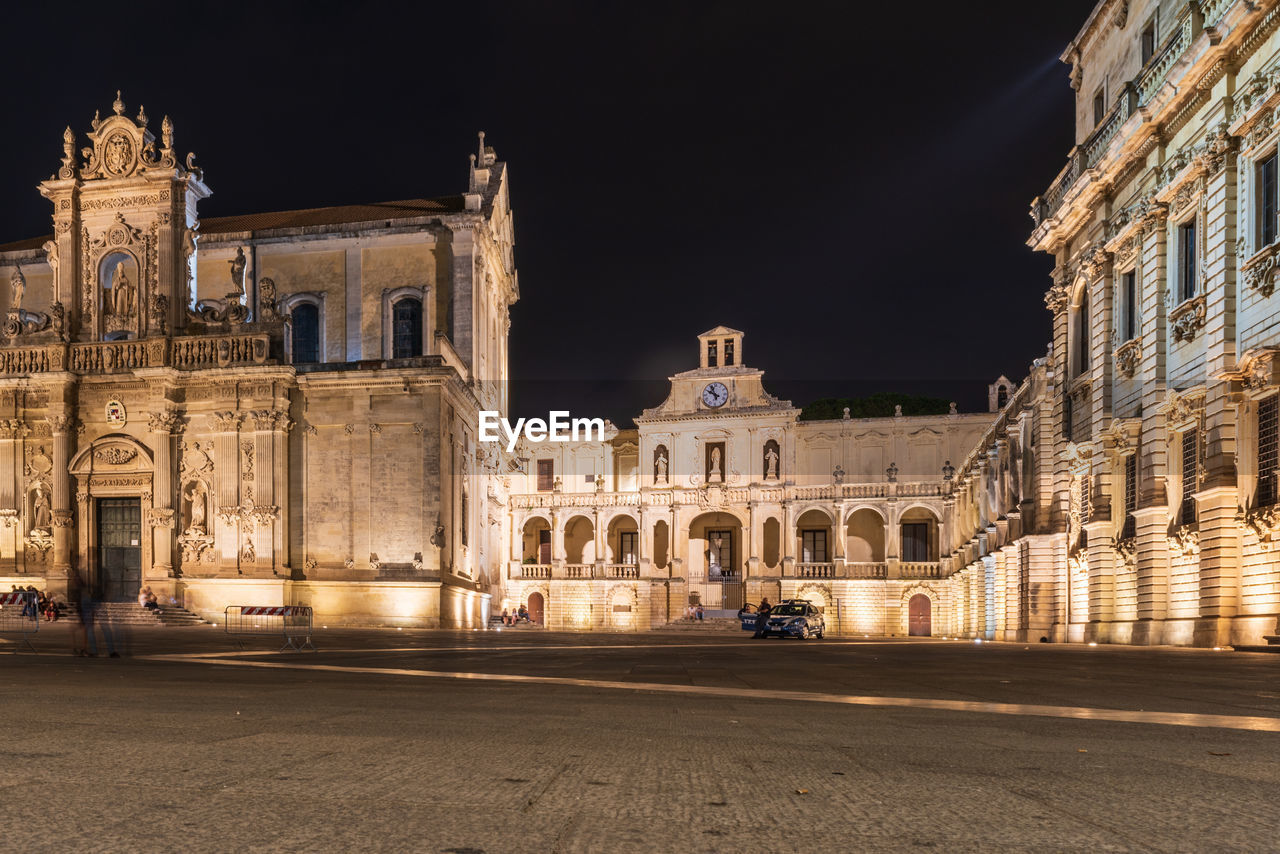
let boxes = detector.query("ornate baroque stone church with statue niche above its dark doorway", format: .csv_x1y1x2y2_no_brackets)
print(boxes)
0,97,518,626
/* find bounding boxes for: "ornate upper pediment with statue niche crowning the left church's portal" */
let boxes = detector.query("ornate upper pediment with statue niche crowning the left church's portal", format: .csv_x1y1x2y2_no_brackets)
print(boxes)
40,92,210,342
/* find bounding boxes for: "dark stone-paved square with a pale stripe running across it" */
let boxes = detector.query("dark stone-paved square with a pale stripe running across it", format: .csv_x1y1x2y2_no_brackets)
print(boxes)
0,626,1280,854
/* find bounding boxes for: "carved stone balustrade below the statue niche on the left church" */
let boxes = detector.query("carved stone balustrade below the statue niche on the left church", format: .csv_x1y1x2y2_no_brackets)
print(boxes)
0,333,271,375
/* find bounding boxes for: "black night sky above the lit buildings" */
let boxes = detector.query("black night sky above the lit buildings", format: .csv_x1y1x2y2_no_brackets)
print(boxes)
0,0,1093,421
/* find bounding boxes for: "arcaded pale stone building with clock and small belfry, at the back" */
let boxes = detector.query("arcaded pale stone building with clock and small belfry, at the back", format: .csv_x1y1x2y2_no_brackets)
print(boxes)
495,326,1007,635
